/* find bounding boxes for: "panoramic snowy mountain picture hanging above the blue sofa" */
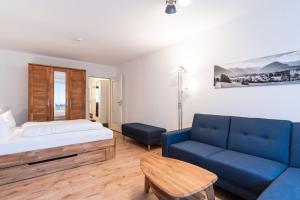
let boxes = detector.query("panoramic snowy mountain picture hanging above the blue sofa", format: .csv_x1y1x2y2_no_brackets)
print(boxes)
214,51,300,88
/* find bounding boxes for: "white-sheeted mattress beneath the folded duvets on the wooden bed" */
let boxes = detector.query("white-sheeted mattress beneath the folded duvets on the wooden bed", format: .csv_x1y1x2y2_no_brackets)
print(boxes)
0,127,113,156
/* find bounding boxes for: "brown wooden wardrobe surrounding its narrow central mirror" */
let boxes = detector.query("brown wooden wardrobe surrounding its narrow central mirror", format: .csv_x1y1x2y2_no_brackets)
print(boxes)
28,63,86,121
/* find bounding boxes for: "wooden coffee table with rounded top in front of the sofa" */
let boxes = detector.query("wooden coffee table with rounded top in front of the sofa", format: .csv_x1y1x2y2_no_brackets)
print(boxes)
141,155,218,200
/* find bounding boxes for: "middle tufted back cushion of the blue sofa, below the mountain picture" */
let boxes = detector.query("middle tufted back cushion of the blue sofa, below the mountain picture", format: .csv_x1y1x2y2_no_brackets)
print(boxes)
228,117,292,164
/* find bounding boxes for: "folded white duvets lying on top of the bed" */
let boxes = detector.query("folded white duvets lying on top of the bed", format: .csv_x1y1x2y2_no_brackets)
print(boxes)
22,119,103,137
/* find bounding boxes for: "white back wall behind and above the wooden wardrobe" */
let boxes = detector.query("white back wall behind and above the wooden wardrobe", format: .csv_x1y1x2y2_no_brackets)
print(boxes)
0,50,118,124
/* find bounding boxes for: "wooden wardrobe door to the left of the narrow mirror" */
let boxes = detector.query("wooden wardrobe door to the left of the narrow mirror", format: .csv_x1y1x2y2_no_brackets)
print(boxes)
28,64,53,121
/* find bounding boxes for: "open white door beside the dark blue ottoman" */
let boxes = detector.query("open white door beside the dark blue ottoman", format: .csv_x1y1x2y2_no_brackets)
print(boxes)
110,76,123,132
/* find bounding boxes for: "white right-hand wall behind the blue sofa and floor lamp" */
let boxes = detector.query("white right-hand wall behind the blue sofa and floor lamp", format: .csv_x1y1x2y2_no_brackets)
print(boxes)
120,0,300,130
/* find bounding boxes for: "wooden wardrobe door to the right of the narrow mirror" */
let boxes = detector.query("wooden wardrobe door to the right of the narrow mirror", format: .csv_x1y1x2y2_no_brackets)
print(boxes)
68,69,86,119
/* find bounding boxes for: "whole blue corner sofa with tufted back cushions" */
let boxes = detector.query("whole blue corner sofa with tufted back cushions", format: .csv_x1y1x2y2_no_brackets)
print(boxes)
162,114,300,200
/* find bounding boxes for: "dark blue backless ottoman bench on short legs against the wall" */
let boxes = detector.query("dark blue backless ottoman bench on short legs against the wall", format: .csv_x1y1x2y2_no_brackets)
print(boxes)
122,123,167,151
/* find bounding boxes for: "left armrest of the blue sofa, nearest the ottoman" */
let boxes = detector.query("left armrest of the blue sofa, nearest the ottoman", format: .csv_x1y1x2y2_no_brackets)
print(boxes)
162,128,192,157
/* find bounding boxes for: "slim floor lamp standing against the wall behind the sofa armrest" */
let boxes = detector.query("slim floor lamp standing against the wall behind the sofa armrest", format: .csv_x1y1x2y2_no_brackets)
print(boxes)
177,66,187,130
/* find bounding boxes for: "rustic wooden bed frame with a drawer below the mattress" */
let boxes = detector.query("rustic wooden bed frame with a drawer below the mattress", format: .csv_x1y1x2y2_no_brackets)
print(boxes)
0,139,116,185
